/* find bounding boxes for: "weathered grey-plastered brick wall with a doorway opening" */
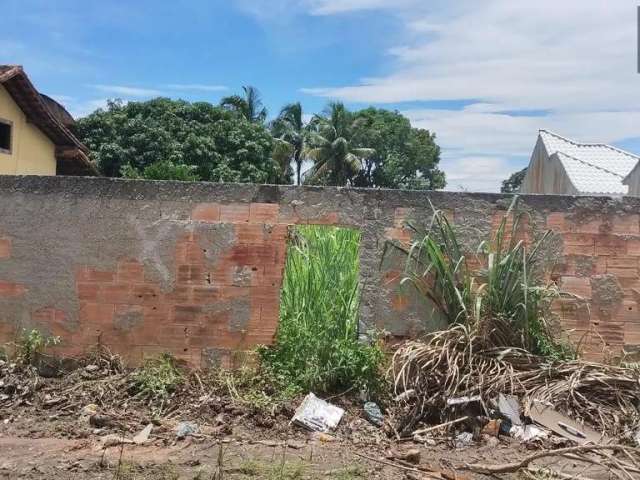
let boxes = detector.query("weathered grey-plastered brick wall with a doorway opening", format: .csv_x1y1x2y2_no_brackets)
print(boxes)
0,176,640,365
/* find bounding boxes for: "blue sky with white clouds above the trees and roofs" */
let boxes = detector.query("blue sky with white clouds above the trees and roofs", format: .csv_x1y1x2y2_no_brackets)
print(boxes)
0,0,640,191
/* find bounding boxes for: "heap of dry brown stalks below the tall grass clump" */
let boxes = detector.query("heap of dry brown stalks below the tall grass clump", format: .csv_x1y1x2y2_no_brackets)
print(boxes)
391,326,640,436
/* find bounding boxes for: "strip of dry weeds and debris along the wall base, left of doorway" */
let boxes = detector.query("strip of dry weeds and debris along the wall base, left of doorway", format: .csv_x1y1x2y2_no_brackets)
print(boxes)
0,346,300,431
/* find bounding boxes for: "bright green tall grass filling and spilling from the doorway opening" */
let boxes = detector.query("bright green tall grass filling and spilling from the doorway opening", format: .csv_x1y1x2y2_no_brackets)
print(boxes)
261,226,383,392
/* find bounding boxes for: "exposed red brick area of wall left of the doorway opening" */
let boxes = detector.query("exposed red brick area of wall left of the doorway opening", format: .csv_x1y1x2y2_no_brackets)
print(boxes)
0,203,344,366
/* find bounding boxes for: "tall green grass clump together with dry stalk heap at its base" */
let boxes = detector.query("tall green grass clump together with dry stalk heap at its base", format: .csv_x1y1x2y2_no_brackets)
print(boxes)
380,198,640,478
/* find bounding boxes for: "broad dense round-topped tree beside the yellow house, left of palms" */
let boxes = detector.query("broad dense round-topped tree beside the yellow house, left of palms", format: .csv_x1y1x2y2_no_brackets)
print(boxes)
76,98,283,183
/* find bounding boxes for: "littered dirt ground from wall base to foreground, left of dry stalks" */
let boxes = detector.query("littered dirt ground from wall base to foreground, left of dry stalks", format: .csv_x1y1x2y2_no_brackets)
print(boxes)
0,358,624,480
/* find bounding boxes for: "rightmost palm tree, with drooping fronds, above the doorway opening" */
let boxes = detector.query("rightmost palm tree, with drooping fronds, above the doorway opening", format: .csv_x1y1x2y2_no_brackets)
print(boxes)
304,102,375,185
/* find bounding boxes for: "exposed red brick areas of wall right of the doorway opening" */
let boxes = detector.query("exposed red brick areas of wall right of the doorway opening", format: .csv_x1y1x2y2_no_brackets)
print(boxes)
384,208,640,358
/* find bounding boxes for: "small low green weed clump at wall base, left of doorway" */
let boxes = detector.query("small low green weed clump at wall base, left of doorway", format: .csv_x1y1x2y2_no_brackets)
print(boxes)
133,353,184,398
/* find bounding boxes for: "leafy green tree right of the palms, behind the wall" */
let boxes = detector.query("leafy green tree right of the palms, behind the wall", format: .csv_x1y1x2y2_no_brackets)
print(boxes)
353,107,446,189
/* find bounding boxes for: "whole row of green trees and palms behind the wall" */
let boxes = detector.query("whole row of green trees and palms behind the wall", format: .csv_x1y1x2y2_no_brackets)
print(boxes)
75,94,445,189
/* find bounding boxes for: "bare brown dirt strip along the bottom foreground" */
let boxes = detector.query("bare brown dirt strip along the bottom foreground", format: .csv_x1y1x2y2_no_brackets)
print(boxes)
0,412,526,480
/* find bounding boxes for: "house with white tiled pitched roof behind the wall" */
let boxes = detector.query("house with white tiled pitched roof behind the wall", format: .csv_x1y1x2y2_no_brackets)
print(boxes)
520,130,640,196
